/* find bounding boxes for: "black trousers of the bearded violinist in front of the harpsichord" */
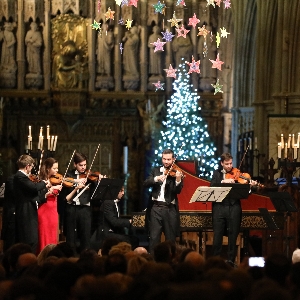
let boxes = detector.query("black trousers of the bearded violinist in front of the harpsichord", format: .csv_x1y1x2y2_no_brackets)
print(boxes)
149,204,178,254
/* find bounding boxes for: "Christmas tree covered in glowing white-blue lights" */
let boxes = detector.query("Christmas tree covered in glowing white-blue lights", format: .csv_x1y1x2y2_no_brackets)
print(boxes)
155,60,218,179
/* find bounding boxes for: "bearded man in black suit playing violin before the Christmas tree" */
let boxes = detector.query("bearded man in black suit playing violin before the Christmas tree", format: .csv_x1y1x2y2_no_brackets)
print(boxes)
144,149,183,254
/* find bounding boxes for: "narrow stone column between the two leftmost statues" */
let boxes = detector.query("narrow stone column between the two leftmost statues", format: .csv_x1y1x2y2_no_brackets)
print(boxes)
17,0,25,90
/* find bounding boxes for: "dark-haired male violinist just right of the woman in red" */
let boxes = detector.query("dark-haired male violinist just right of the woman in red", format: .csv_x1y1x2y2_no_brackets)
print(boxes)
59,152,101,253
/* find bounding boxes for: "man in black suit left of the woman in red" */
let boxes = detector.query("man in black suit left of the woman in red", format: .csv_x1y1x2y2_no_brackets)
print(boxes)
13,155,50,254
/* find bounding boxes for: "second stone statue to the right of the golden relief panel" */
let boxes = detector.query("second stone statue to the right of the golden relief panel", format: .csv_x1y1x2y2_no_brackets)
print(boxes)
122,26,140,78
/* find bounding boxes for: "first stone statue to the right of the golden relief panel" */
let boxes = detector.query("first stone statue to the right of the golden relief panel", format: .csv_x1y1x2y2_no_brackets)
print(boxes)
97,25,114,76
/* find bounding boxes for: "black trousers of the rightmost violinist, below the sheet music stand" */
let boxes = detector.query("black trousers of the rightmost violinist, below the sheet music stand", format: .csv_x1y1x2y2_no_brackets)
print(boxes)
212,200,242,262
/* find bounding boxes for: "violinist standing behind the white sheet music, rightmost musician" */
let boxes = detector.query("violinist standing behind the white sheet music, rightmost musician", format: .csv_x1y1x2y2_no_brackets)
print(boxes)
211,153,257,267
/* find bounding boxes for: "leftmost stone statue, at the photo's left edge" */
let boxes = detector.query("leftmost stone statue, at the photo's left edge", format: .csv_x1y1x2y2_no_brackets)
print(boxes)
0,22,17,73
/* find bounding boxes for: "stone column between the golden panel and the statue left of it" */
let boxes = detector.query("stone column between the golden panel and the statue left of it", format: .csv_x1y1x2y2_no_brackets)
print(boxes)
43,0,52,91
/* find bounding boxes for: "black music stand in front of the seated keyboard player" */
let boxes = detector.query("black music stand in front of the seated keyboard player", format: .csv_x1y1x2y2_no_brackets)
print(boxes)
96,178,124,201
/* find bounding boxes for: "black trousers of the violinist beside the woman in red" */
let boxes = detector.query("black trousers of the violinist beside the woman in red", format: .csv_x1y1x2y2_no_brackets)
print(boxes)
64,204,92,252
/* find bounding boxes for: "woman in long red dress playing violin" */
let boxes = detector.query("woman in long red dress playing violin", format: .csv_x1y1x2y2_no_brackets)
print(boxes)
38,157,61,253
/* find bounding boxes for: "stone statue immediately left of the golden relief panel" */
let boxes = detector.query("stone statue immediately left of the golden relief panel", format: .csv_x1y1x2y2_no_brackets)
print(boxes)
25,22,43,74
